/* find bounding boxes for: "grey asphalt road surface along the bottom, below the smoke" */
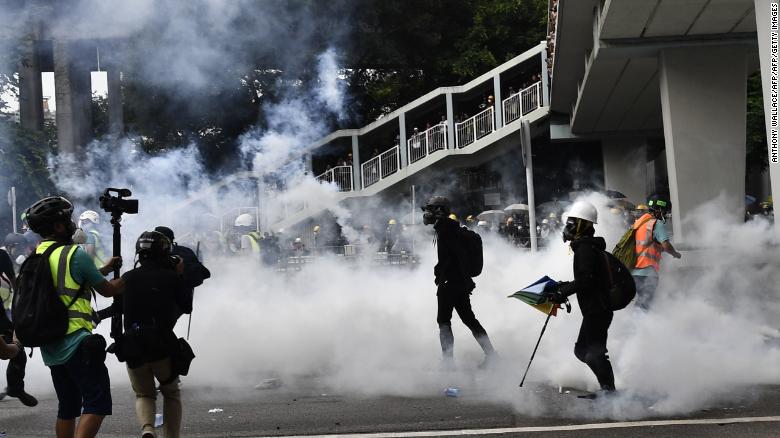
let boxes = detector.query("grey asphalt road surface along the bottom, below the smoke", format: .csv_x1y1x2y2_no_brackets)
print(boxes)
0,379,780,438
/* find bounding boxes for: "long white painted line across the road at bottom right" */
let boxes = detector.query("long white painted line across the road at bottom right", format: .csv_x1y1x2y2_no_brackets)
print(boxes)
258,417,780,438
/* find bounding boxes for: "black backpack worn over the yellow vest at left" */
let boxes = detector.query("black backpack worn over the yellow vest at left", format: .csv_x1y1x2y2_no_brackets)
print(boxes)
11,243,82,347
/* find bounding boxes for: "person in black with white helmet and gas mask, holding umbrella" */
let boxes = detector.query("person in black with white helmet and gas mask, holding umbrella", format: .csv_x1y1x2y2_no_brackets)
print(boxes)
549,202,615,393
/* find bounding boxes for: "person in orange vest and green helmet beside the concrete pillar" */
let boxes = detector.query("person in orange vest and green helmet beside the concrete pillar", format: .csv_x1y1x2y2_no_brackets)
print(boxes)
629,195,682,311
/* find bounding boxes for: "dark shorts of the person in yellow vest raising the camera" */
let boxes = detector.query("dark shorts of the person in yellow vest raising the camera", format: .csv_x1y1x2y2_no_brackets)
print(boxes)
50,340,111,420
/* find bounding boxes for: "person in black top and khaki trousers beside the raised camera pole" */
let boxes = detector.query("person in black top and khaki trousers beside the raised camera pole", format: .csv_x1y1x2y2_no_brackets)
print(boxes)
122,231,191,438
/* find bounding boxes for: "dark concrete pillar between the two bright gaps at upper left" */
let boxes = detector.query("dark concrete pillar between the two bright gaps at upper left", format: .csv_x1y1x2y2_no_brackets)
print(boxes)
53,40,92,153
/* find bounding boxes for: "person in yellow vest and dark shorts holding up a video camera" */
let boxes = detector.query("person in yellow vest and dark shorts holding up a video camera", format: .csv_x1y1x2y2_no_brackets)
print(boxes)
25,196,122,438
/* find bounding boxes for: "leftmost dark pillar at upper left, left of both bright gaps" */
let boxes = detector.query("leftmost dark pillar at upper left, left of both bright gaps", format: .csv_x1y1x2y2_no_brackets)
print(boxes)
19,35,43,131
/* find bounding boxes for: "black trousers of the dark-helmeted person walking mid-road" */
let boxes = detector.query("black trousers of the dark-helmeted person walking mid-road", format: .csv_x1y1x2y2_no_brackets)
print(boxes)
436,286,493,358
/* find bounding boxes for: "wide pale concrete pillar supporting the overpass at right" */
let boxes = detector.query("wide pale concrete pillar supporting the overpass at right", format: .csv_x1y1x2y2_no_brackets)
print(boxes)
660,46,747,242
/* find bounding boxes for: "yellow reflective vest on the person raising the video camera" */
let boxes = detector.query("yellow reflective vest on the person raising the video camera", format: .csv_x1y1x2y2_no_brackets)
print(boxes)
35,240,94,335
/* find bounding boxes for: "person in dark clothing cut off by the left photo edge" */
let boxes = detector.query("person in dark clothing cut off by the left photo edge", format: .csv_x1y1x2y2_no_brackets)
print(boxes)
0,243,38,406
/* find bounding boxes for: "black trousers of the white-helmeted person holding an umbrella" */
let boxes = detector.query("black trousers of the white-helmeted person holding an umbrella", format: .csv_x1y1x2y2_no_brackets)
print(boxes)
574,312,615,390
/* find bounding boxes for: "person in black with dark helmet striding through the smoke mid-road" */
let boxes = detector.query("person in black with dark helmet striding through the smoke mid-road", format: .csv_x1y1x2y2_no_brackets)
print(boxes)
423,196,495,368
